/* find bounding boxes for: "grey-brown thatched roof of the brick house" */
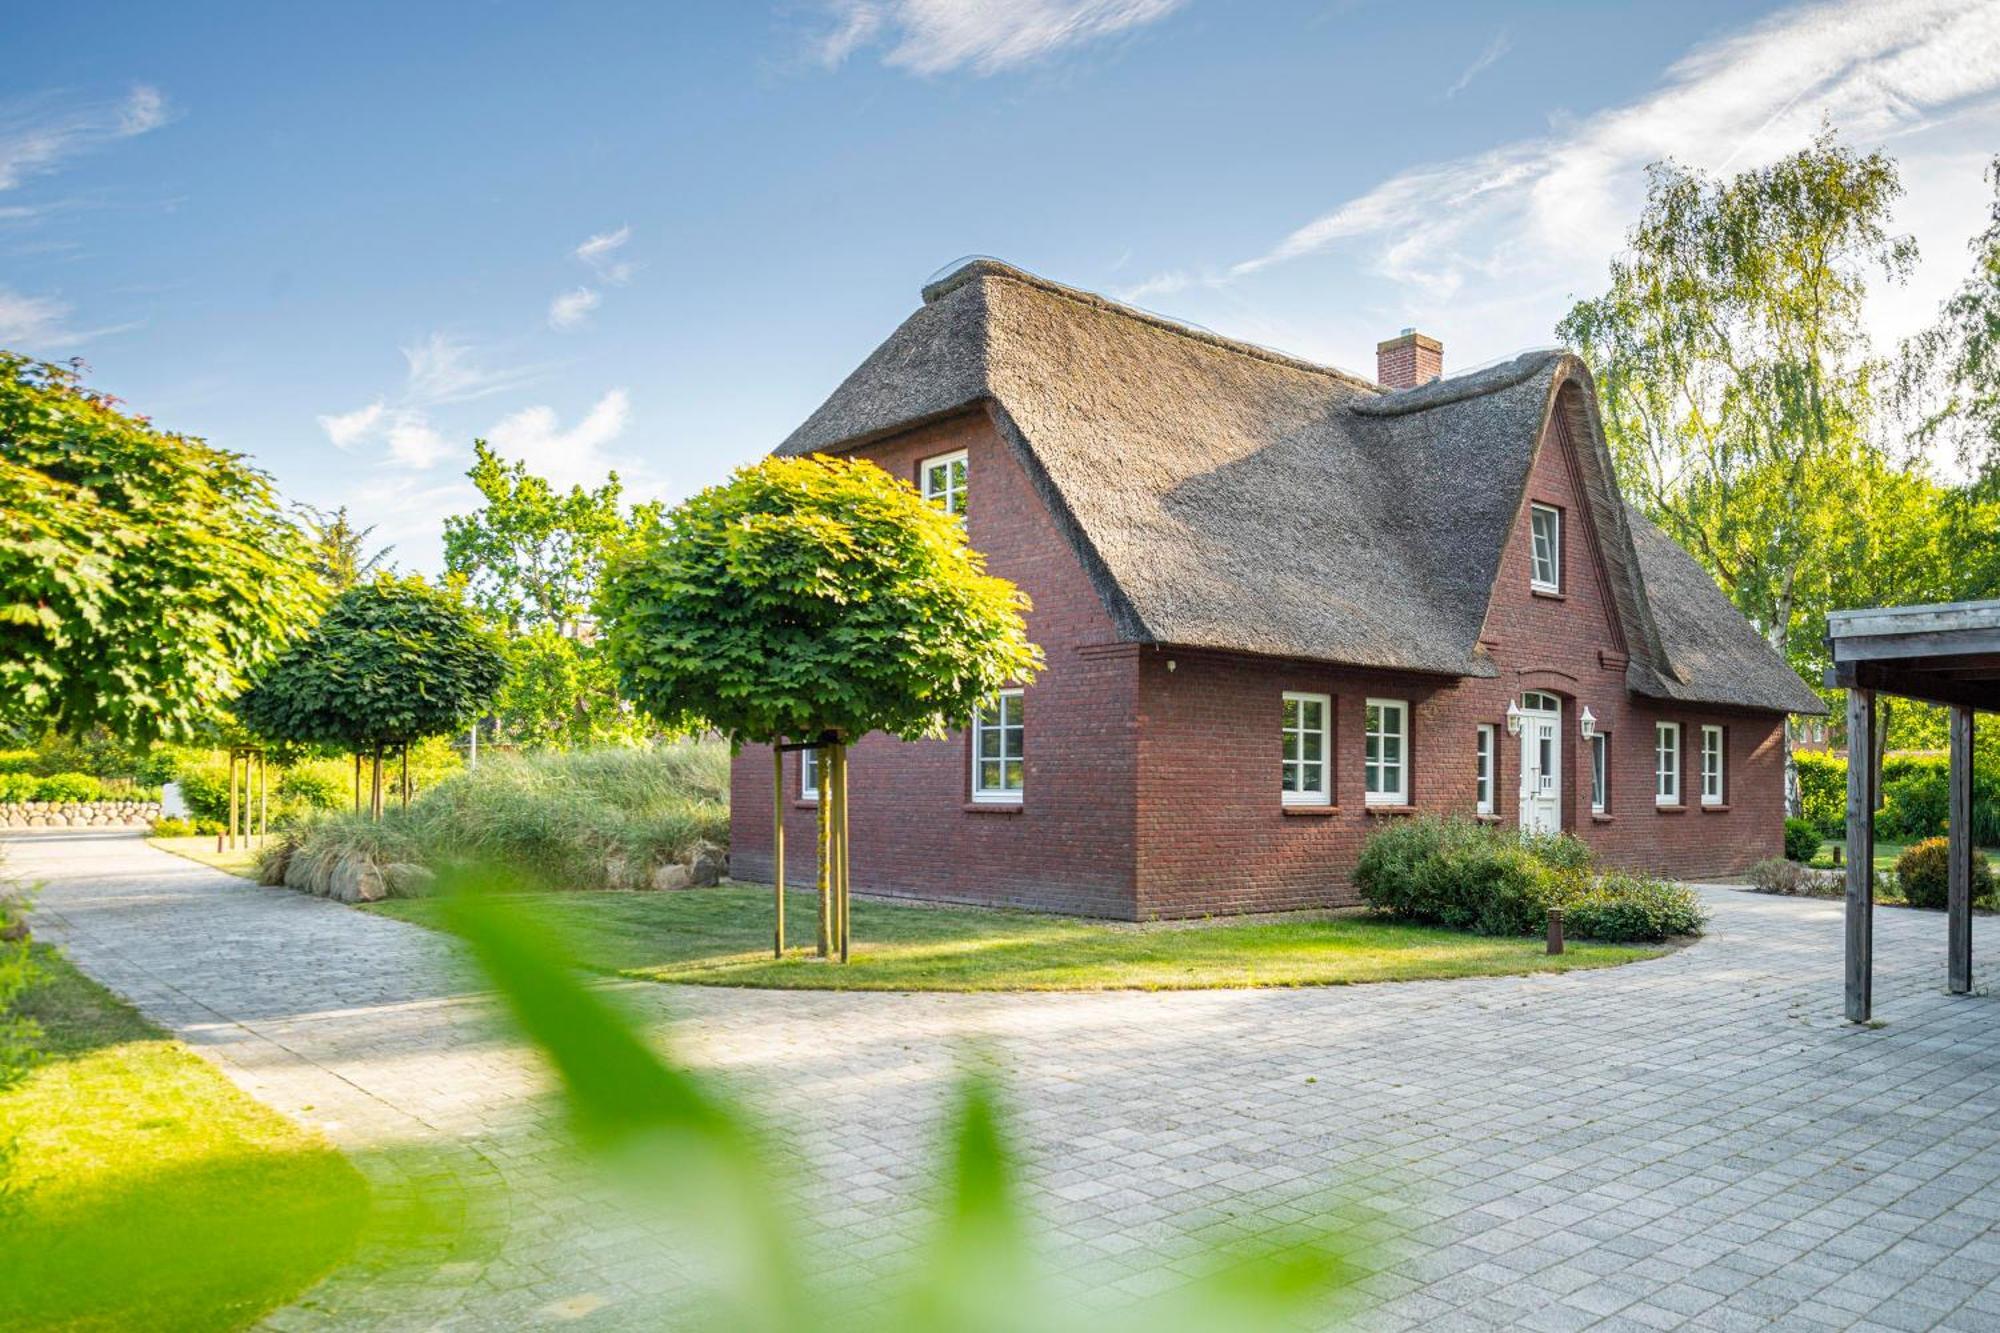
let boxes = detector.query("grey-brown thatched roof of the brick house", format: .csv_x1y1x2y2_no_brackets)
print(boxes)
778,260,1818,709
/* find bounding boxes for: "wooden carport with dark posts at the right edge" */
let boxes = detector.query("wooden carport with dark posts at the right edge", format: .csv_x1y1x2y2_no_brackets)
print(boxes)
1826,602,2000,1023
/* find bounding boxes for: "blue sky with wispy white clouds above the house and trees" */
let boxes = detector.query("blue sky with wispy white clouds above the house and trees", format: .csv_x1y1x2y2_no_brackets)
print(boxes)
11,0,2000,570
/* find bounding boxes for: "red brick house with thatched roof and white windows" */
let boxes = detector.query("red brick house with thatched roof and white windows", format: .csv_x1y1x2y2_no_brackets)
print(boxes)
730,260,1820,919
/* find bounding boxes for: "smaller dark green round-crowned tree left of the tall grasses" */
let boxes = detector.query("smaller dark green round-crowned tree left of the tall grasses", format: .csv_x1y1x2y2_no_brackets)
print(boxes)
236,576,506,819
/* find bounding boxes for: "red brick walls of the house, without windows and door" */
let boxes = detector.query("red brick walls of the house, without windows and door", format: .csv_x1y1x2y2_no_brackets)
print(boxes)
730,394,1784,919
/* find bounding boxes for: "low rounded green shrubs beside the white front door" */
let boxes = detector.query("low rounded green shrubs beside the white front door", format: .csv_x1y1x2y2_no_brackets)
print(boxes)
1354,817,1706,941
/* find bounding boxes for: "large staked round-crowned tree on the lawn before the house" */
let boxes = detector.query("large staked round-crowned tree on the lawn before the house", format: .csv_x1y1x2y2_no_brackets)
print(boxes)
600,454,1042,953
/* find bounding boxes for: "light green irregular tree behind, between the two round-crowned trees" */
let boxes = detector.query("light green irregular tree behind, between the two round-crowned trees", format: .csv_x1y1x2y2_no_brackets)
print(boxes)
444,440,660,638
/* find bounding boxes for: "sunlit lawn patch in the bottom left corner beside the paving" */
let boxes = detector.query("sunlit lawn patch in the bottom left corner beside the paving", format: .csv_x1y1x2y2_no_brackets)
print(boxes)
0,940,368,1329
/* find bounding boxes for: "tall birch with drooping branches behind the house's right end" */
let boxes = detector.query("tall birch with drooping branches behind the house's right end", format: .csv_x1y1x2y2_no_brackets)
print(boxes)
1556,130,1916,664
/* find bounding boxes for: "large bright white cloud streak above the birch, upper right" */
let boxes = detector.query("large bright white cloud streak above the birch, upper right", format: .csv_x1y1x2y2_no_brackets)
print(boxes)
1134,0,2000,364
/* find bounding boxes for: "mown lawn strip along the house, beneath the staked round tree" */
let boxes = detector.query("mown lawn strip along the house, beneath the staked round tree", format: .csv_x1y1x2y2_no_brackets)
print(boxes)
366,885,1662,991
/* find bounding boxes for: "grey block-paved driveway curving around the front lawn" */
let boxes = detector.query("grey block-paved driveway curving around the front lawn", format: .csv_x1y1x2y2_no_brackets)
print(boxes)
8,837,2000,1329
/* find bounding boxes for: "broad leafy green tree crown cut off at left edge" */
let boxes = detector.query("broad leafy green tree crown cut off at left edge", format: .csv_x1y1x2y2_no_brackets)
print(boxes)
0,352,322,745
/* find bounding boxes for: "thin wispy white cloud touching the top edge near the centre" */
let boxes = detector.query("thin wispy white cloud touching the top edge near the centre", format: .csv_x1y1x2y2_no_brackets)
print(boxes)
812,0,1184,74
